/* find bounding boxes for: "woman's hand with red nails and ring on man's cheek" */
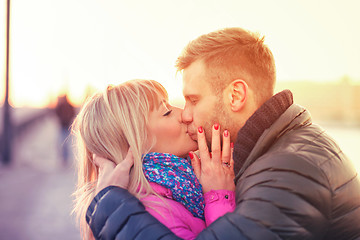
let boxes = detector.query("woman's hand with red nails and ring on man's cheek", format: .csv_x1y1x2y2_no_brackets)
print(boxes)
189,124,235,193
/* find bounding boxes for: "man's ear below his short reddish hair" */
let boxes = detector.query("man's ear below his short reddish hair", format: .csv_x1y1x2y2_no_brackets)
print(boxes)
228,79,249,112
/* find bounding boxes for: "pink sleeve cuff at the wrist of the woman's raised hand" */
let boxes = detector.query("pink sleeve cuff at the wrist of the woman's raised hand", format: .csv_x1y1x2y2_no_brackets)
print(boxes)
204,190,236,226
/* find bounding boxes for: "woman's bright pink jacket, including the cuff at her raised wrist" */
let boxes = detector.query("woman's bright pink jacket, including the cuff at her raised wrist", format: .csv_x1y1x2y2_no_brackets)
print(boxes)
141,183,235,239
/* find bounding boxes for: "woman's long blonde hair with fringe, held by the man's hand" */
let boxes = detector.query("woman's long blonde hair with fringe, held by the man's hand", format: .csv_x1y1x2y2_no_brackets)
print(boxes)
72,80,168,239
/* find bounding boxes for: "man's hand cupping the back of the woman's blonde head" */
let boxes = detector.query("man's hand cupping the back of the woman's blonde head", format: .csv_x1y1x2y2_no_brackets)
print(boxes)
93,149,134,195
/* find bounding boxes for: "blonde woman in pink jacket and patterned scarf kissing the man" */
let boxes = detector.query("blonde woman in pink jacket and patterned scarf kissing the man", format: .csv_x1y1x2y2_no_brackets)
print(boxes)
73,80,235,239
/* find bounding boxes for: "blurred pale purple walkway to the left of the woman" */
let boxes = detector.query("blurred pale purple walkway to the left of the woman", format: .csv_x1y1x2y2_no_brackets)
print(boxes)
0,111,80,240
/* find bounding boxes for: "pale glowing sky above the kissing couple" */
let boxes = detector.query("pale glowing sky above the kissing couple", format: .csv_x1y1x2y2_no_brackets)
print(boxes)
0,0,360,107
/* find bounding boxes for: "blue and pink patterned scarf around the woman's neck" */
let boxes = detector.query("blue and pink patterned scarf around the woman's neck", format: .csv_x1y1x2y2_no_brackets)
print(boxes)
143,152,204,219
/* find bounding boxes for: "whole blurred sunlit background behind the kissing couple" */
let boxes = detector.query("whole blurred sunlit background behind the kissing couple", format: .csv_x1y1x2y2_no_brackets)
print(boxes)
0,0,360,240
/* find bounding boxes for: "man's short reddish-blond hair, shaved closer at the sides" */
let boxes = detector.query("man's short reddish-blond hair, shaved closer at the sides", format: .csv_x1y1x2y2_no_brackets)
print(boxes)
176,28,276,104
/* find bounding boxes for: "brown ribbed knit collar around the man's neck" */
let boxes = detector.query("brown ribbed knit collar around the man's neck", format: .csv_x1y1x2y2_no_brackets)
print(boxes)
233,90,293,175
